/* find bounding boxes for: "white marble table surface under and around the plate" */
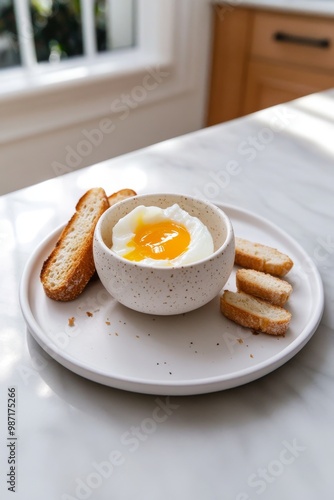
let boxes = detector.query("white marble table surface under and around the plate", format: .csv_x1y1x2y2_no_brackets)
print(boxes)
0,91,334,500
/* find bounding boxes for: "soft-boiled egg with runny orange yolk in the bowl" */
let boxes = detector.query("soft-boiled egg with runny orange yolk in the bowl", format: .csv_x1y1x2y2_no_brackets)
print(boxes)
111,203,214,267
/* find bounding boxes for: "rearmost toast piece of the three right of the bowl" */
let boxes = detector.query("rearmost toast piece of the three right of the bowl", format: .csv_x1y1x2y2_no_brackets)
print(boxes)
235,237,293,277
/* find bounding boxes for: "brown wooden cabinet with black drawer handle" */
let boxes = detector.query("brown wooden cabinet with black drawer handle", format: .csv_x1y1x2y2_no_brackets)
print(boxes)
207,5,334,125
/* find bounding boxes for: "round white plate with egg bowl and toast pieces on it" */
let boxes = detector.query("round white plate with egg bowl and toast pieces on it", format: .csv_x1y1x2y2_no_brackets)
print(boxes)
20,187,319,396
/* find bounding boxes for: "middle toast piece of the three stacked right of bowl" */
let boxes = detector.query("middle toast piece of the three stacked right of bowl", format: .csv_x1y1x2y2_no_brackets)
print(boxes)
236,269,292,306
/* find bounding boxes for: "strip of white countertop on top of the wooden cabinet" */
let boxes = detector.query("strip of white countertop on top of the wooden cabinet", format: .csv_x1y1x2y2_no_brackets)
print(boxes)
214,0,334,16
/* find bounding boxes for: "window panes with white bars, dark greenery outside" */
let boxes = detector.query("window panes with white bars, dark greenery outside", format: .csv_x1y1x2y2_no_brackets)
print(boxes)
0,0,136,70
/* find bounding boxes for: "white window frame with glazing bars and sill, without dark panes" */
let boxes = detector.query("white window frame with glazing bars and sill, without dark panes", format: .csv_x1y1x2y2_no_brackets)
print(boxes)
0,0,184,146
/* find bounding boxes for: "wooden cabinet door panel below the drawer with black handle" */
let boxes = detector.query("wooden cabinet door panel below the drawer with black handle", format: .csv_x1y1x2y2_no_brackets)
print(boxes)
242,60,334,114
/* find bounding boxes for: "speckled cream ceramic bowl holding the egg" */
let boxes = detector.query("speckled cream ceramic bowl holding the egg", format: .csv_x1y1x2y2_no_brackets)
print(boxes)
93,194,234,315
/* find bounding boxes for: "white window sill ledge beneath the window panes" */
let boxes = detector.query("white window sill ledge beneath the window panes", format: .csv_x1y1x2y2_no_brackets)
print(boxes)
0,51,187,144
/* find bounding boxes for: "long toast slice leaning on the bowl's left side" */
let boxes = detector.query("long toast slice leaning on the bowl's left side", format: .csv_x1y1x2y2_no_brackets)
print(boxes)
40,188,109,302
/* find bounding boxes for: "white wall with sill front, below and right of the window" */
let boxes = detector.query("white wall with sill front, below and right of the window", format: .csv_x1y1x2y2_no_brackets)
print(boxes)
0,0,212,194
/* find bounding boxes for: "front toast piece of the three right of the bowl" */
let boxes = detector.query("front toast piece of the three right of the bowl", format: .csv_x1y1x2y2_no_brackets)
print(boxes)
220,290,291,335
